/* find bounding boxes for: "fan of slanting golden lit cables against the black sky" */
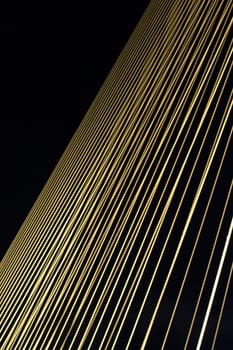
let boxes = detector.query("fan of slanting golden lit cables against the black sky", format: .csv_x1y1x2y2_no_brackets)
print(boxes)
0,0,233,349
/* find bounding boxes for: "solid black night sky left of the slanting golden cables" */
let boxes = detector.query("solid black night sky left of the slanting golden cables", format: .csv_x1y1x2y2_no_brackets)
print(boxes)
0,0,149,258
